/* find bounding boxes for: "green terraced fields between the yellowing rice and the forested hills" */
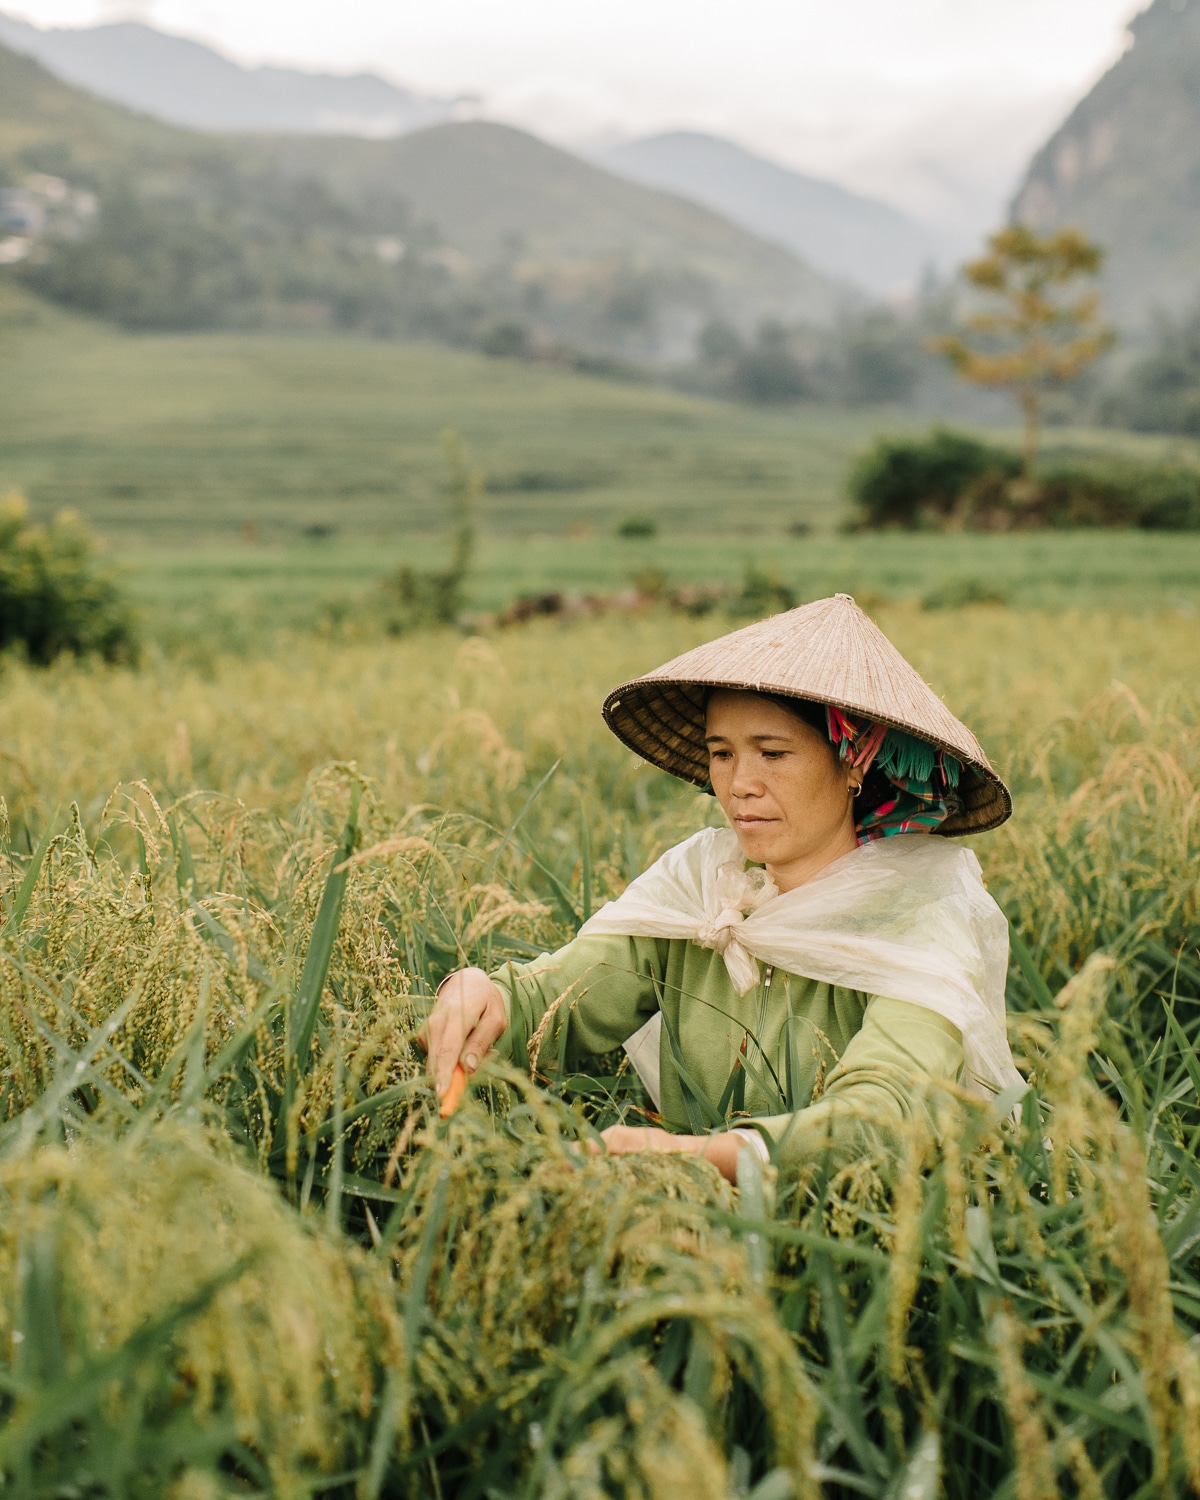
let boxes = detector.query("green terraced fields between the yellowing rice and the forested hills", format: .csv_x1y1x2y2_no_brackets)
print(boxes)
11,281,1200,644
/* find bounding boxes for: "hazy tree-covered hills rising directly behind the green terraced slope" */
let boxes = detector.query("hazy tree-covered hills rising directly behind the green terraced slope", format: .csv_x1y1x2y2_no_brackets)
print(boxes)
0,48,854,360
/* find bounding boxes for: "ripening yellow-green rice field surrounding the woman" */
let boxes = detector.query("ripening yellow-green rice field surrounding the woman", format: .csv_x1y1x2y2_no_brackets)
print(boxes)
0,606,1200,1500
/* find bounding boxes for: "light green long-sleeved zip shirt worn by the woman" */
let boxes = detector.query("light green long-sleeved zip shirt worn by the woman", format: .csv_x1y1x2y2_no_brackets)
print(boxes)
492,936,963,1169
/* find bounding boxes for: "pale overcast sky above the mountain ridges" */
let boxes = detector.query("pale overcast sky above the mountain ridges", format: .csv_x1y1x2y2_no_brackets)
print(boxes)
0,0,1142,237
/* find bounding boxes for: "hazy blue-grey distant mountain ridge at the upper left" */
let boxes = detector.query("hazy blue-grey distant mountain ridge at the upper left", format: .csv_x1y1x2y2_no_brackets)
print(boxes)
0,15,461,137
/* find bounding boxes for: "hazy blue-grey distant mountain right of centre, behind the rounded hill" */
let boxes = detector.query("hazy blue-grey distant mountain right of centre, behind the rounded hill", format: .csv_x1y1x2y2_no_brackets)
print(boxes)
600,131,936,297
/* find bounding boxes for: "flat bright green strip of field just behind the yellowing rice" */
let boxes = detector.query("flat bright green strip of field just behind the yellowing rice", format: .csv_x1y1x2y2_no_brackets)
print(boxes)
123,533,1200,647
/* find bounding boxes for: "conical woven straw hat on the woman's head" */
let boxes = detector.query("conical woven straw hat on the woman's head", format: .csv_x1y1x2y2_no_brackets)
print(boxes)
605,594,1013,834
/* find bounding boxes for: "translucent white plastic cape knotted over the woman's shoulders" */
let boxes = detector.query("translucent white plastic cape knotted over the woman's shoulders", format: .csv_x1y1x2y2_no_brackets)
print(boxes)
579,828,1023,1100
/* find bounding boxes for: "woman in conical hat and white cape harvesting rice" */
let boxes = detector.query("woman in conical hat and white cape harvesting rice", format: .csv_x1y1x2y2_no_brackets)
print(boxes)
429,594,1022,1181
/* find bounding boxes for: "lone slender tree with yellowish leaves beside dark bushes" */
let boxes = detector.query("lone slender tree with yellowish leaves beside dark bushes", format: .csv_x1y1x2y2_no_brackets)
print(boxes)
930,224,1115,479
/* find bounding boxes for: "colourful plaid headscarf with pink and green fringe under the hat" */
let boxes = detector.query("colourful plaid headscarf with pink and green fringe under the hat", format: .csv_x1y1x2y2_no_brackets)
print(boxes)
825,708,962,843
